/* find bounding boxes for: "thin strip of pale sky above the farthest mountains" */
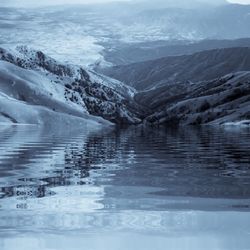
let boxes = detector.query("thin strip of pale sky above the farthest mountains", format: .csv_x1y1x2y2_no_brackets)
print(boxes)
0,0,250,6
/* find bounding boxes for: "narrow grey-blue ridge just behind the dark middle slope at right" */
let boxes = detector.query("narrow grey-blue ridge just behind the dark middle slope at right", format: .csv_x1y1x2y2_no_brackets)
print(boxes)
102,38,250,66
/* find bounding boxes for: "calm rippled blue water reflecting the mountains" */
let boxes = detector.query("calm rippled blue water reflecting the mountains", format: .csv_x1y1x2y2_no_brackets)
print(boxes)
0,126,250,250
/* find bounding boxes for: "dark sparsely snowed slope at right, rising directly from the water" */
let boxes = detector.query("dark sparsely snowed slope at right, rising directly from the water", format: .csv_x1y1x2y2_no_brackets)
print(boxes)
143,71,250,125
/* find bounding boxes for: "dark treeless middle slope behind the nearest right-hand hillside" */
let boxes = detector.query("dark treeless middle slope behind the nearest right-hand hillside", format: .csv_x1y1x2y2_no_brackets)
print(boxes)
104,47,250,90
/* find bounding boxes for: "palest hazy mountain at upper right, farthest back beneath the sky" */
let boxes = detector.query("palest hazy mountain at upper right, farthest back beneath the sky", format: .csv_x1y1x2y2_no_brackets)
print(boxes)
120,4,250,41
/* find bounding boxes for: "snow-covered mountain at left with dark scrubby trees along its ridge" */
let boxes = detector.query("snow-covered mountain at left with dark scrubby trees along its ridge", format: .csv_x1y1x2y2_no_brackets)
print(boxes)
0,46,140,124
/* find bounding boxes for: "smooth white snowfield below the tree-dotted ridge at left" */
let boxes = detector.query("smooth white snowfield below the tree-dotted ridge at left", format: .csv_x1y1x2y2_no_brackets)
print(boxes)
0,61,111,126
